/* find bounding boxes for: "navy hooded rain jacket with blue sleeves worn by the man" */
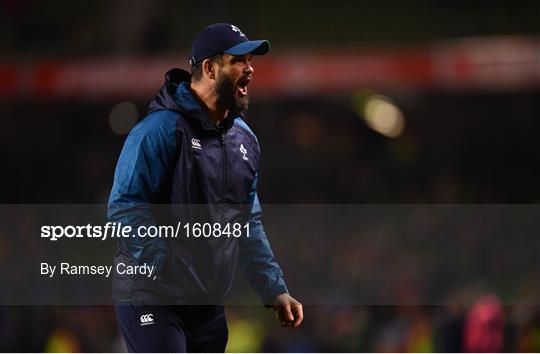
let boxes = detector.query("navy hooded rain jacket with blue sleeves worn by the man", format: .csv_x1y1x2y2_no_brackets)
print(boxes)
108,69,287,304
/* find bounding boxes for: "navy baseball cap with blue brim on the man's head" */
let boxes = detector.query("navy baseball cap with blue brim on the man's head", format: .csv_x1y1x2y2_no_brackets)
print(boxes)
188,23,270,65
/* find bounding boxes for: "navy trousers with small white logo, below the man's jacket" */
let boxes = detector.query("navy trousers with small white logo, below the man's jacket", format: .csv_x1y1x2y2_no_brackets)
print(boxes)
115,303,228,353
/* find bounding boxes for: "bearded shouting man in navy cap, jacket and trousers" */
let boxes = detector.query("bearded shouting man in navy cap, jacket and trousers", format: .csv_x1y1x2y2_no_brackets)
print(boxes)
108,23,303,352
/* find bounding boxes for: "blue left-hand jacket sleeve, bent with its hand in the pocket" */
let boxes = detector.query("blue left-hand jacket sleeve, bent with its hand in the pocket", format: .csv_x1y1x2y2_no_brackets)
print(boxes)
107,111,176,275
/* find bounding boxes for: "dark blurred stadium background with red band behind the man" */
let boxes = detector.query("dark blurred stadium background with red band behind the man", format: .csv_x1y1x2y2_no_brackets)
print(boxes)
0,0,540,352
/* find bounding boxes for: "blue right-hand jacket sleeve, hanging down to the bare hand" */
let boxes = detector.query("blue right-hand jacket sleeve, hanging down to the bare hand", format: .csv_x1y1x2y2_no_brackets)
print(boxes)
240,176,288,305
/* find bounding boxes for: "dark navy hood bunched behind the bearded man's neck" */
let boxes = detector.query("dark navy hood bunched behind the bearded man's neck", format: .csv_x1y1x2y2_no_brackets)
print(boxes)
148,68,233,130
